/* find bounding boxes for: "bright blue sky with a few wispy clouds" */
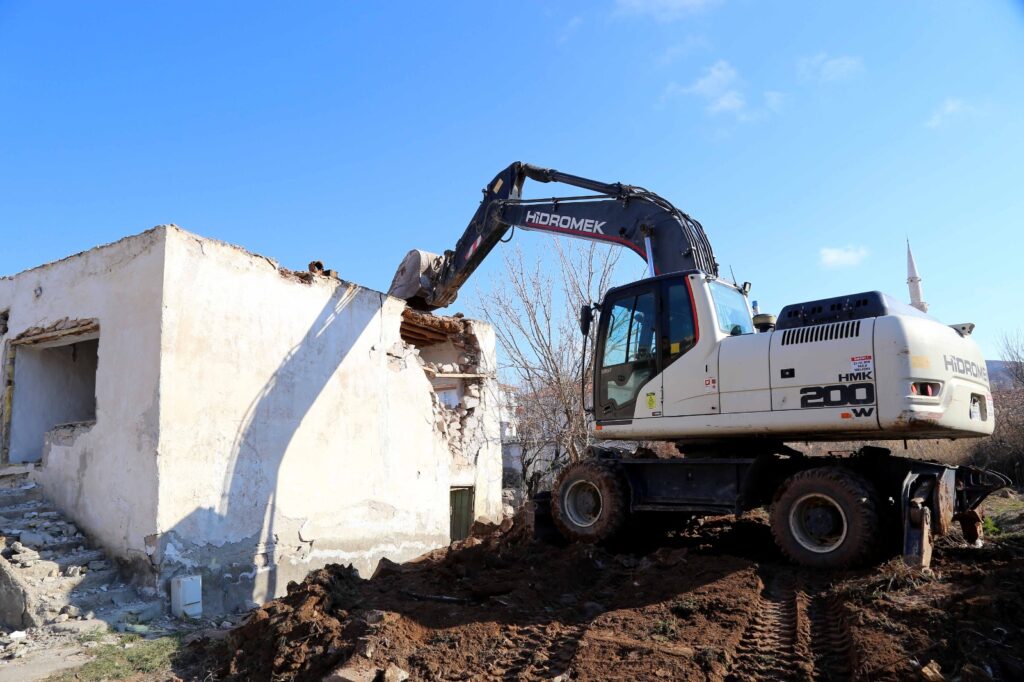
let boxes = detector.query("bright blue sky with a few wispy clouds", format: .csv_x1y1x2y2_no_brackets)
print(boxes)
0,0,1024,357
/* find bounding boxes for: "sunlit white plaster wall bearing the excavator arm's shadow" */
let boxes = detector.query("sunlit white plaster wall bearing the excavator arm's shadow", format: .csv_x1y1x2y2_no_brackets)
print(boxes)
155,230,456,604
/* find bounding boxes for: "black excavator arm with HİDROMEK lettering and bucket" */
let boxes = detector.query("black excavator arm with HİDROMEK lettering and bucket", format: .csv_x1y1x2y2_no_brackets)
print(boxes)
389,162,718,309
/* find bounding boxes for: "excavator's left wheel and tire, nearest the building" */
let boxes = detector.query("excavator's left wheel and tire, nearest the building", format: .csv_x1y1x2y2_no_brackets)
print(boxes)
551,460,629,543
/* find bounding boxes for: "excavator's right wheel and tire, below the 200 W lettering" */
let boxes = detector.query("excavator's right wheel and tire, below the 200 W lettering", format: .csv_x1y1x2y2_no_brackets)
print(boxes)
771,466,879,568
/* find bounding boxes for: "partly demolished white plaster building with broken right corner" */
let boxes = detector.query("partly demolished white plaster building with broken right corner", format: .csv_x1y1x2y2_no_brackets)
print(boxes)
0,225,502,613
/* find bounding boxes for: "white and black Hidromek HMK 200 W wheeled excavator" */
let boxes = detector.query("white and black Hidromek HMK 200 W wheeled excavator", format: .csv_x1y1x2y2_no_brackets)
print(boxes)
390,163,1010,568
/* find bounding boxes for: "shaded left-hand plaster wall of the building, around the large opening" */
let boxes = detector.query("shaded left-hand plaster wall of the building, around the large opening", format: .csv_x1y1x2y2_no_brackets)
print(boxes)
0,229,164,555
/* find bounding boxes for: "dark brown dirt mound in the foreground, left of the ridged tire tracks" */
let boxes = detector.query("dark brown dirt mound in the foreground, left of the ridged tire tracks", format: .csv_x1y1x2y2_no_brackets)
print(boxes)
211,516,758,680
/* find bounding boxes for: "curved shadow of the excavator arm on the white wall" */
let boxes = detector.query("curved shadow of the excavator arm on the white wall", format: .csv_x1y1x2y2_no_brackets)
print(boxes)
158,285,380,612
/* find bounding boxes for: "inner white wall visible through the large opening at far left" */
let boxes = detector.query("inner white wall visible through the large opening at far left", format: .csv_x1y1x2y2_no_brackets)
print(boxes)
8,339,98,463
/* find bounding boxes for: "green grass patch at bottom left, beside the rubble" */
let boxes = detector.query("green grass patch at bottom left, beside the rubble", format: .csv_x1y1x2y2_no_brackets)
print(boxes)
47,633,180,682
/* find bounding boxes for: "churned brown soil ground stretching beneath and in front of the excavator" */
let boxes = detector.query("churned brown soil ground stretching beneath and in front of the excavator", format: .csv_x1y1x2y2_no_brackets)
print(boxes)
24,491,1024,682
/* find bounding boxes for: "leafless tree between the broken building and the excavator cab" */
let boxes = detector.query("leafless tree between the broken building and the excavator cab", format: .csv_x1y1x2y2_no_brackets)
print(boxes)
476,240,621,493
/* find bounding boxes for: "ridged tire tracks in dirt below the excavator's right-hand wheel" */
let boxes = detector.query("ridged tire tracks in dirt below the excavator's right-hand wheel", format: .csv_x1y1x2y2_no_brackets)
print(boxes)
727,568,852,682
